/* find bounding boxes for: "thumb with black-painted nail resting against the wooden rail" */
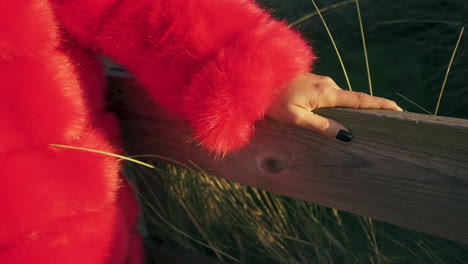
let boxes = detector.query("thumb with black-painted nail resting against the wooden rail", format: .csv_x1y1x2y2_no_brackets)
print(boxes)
296,109,353,142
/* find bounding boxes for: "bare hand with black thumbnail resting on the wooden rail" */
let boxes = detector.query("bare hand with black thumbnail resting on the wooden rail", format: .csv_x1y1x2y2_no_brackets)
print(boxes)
266,73,403,141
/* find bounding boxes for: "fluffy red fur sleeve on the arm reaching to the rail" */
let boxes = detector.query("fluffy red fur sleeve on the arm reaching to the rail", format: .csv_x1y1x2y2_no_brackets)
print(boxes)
53,0,313,153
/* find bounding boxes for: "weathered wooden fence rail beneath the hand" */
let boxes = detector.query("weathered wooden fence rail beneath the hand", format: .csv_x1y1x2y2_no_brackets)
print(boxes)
110,78,468,243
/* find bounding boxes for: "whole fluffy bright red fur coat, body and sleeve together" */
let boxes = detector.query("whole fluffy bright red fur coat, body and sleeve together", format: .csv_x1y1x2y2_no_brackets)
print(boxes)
0,0,313,264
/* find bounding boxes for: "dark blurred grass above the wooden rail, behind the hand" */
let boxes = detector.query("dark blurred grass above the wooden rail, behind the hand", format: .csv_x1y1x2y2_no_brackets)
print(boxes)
263,0,468,119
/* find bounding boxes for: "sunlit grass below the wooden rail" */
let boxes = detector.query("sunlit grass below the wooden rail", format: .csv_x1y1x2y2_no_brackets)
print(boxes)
127,161,468,264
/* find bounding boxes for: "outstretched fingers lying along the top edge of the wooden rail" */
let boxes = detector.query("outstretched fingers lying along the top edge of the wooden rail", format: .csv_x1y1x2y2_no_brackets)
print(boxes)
330,90,403,111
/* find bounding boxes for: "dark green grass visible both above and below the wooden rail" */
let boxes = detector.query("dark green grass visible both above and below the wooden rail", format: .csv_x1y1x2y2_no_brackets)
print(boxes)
121,0,468,264
